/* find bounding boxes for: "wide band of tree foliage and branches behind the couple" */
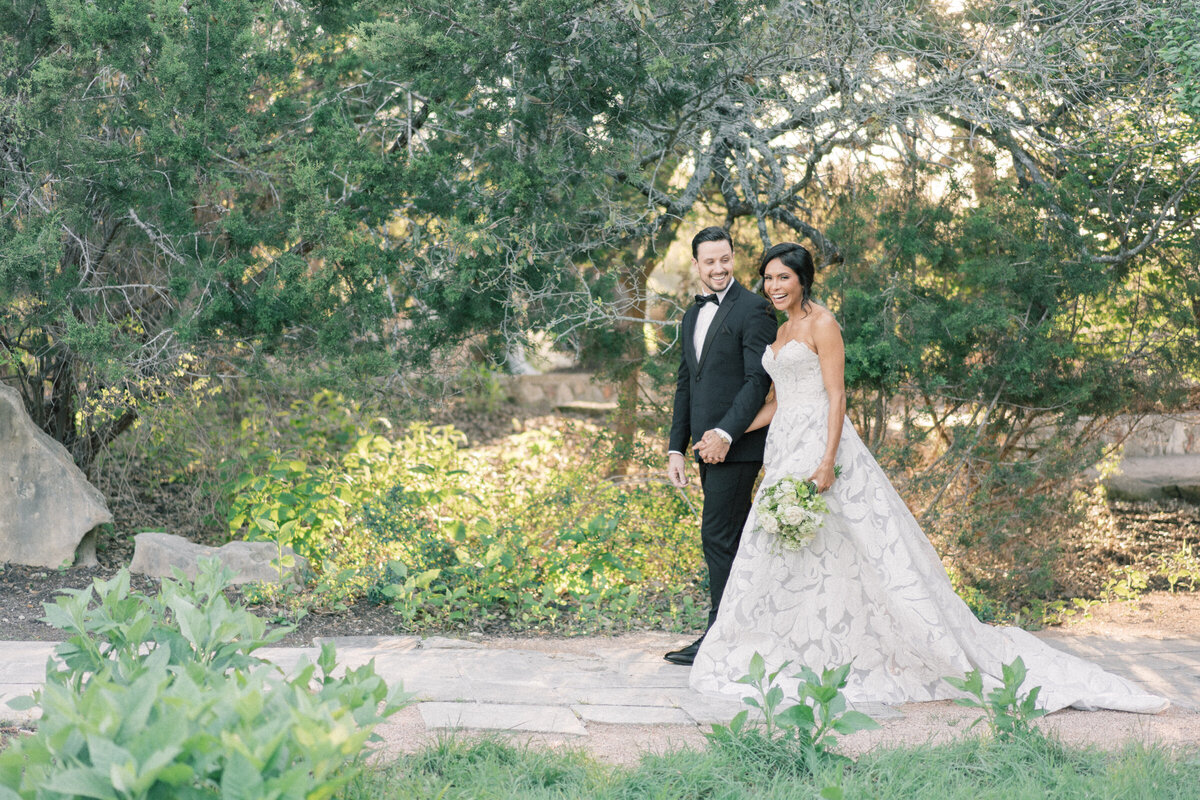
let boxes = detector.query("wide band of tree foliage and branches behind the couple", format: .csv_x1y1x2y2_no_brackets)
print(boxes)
0,0,1200,497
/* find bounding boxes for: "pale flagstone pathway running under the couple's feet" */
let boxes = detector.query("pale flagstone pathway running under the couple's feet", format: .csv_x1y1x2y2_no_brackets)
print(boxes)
0,631,1200,762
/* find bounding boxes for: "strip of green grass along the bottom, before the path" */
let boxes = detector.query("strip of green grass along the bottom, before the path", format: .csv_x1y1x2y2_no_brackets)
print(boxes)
342,736,1200,800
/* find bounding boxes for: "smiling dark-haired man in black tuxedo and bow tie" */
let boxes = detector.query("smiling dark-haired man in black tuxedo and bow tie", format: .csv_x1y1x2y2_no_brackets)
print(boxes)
665,228,778,664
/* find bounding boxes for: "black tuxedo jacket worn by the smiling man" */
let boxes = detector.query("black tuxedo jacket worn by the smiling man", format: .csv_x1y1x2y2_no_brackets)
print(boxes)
670,281,779,462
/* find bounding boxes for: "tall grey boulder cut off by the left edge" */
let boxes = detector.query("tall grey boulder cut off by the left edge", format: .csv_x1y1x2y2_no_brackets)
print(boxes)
0,383,113,567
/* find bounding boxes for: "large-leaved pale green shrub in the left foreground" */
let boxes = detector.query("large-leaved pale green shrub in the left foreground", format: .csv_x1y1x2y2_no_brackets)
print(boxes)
0,561,403,800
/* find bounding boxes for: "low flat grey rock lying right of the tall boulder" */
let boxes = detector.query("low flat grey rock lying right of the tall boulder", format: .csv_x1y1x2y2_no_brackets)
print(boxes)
130,533,305,583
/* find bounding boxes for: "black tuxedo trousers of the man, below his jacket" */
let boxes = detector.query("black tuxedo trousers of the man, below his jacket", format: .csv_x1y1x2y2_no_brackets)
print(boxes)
700,461,762,627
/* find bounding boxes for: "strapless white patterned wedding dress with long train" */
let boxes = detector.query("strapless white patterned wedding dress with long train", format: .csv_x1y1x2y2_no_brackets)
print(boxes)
690,341,1168,714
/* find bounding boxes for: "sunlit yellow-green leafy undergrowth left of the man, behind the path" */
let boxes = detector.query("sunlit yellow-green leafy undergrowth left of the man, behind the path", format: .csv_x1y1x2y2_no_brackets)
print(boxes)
222,409,702,630
